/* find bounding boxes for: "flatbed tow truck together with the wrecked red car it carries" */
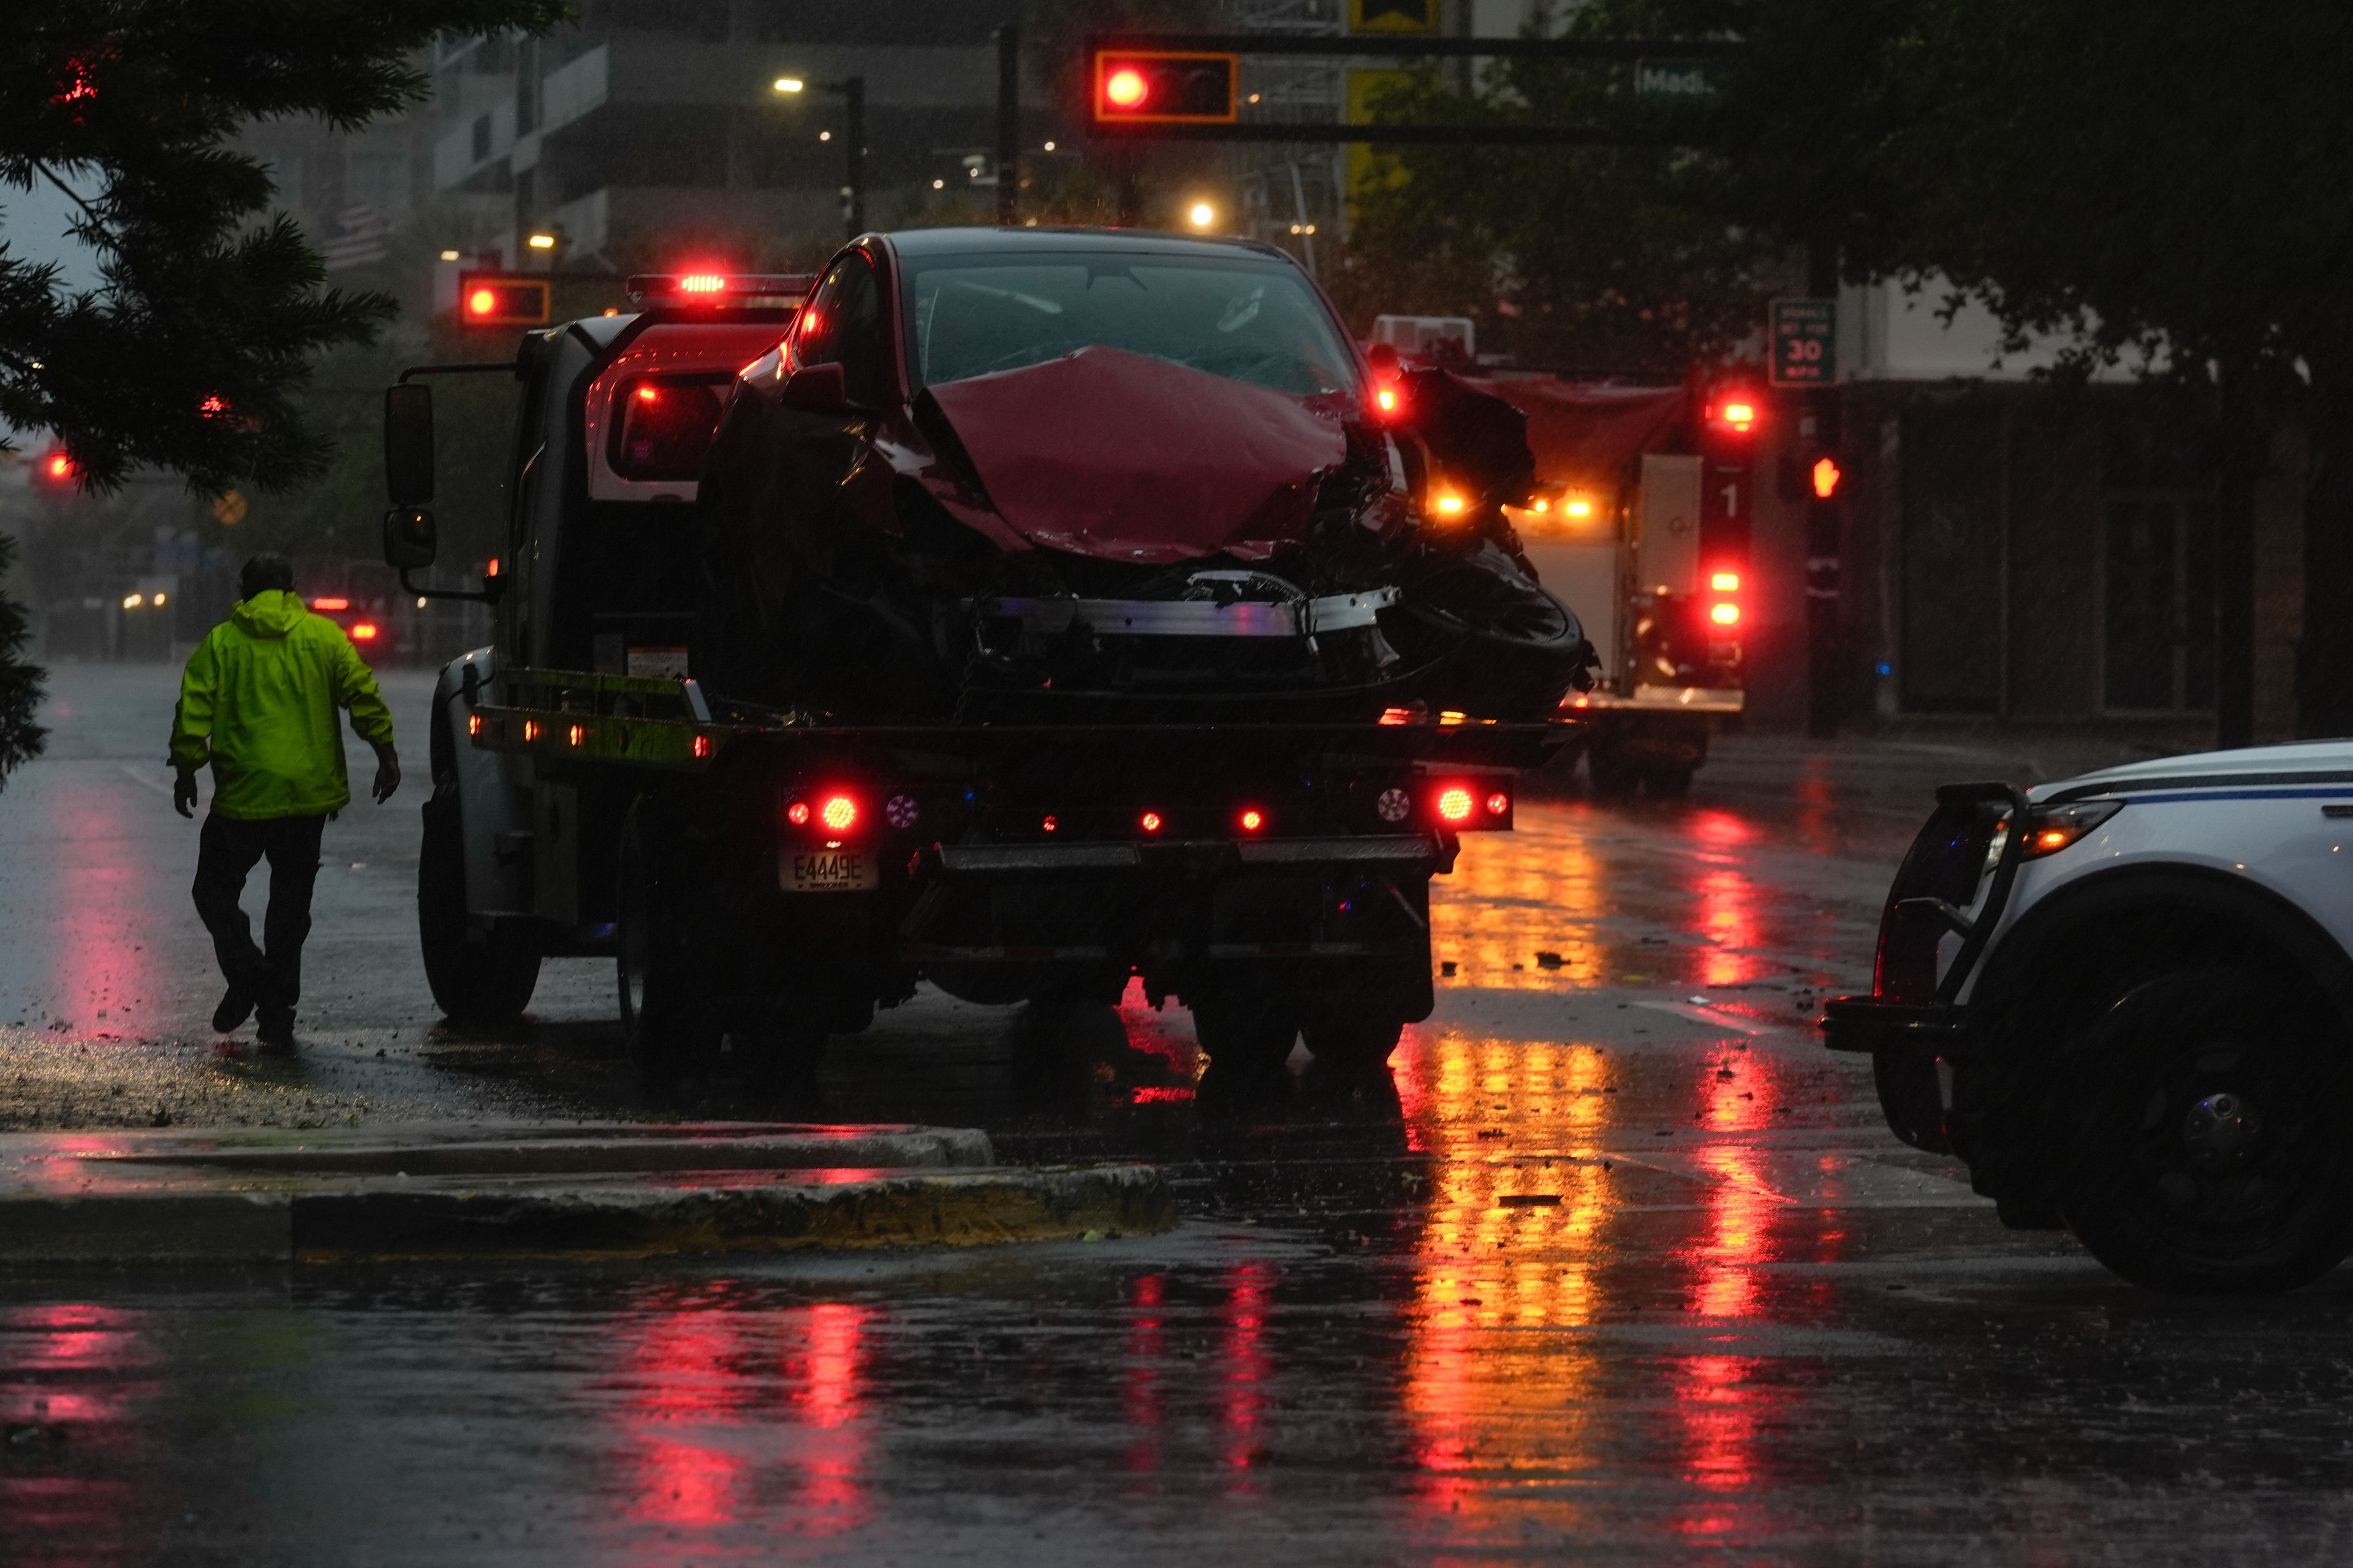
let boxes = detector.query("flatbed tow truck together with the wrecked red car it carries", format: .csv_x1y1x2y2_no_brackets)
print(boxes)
386,231,1588,1099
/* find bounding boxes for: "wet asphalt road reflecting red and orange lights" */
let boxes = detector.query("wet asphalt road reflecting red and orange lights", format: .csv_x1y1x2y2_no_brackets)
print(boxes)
18,666,2353,1563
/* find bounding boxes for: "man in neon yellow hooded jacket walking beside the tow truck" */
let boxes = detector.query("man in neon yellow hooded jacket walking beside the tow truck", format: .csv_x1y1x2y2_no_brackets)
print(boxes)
172,556,400,1055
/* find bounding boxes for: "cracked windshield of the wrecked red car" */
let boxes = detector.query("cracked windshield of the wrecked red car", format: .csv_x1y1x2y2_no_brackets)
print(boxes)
906,254,1358,398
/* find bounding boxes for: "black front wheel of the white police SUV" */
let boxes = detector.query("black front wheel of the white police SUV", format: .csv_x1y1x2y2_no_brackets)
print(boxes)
2054,968,2353,1295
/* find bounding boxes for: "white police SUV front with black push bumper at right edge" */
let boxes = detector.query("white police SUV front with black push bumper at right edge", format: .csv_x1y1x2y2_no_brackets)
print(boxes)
1821,741,2353,1292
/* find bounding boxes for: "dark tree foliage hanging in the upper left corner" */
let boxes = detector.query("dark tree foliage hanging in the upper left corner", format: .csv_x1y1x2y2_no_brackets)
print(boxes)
0,0,569,775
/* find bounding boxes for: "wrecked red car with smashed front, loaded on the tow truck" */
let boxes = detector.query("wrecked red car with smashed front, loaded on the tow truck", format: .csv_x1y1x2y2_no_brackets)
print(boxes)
697,229,1593,723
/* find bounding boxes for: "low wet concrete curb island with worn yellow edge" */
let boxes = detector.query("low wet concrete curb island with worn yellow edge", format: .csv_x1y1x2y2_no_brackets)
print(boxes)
0,1127,1176,1269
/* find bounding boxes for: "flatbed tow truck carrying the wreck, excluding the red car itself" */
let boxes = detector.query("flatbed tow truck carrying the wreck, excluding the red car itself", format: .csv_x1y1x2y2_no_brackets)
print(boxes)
386,240,1572,1102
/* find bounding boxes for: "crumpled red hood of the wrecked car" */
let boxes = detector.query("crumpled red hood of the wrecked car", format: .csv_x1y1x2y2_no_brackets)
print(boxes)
930,346,1348,565
